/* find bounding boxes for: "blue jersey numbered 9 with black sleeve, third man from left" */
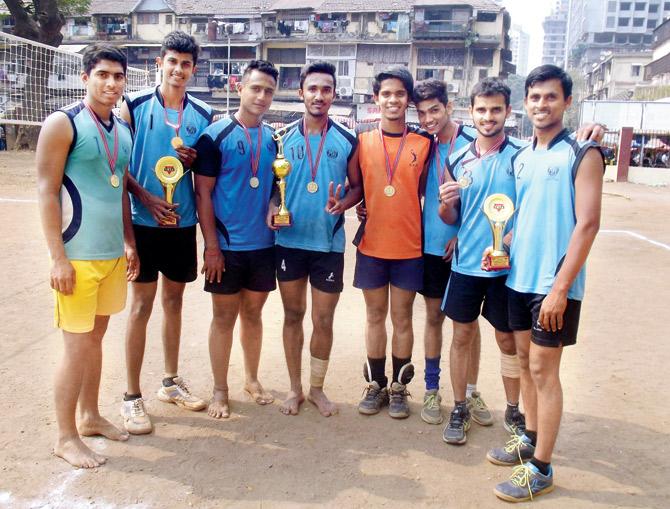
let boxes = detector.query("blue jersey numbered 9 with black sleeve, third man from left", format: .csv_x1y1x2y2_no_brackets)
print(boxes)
194,116,277,251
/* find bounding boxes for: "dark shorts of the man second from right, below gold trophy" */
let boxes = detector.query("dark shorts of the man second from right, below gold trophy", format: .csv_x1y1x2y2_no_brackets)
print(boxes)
442,272,512,332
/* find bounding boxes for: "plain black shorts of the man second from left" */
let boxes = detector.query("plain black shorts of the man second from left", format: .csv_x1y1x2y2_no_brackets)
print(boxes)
133,224,198,283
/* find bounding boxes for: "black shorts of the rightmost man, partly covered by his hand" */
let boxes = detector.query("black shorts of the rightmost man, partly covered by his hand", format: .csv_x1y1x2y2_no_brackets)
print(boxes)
508,288,582,348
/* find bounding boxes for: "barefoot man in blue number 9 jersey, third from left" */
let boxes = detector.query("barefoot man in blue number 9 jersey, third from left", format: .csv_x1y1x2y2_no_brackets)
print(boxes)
194,60,279,419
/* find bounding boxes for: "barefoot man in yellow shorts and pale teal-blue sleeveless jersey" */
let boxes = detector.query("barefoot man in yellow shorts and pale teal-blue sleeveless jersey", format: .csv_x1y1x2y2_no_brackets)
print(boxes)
37,45,139,468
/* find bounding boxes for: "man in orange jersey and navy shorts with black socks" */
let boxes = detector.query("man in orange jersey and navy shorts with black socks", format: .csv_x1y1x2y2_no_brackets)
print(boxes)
354,66,432,419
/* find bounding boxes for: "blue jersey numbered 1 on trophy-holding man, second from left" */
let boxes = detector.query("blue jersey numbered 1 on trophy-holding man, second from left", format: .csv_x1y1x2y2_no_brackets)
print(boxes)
126,87,212,227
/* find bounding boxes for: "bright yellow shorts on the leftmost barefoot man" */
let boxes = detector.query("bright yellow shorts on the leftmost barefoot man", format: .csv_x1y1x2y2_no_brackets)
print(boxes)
54,256,127,333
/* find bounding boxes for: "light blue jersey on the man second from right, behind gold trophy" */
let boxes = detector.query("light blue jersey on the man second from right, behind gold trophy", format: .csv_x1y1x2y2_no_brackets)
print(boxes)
449,137,519,277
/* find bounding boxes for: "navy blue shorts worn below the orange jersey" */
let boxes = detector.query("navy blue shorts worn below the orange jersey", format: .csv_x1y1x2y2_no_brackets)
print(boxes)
354,251,423,292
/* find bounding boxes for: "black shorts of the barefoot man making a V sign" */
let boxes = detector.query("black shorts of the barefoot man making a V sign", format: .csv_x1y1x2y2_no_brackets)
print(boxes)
275,246,344,293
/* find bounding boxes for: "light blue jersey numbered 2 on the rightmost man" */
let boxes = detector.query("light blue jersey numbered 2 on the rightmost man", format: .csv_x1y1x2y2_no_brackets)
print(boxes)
507,129,596,300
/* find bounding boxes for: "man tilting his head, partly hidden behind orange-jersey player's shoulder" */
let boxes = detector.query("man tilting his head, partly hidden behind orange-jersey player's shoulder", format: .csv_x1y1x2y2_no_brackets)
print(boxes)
412,79,493,426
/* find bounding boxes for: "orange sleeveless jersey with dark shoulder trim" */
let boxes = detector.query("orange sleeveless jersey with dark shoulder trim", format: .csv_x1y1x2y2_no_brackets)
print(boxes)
358,122,432,260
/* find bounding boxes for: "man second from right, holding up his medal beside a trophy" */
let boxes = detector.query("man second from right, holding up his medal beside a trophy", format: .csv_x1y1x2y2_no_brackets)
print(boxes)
438,78,524,445
